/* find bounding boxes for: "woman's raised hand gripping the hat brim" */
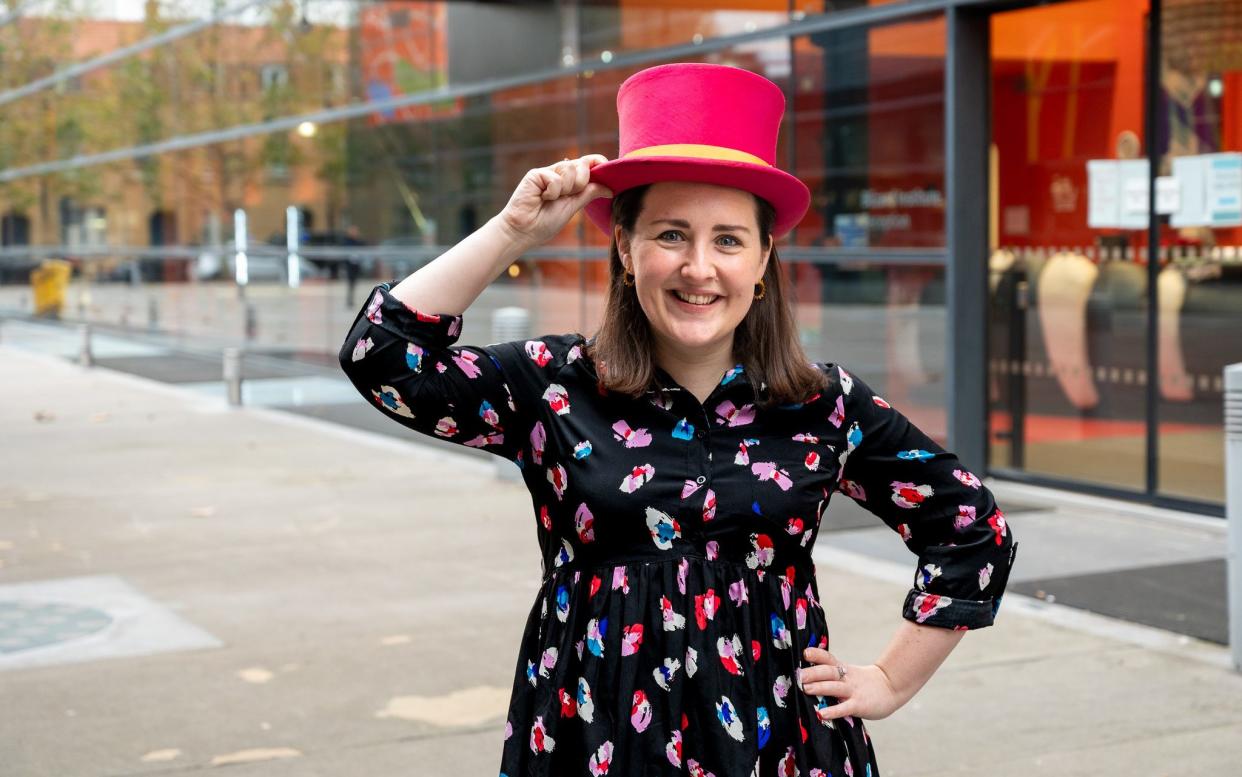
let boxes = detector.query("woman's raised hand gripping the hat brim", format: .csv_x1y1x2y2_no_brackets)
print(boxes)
499,154,612,246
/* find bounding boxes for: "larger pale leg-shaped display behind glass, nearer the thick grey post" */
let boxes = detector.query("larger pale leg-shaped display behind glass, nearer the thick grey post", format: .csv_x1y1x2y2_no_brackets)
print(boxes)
1036,253,1099,410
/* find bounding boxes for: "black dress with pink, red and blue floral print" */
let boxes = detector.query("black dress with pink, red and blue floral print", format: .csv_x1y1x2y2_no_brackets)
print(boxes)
340,284,1017,777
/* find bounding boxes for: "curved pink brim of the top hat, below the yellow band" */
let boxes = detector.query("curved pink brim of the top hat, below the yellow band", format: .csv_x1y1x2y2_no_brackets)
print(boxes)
584,156,811,240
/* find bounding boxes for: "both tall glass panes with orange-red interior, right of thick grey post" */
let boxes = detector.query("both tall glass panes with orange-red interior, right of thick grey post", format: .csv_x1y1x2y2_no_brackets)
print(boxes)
989,0,1242,511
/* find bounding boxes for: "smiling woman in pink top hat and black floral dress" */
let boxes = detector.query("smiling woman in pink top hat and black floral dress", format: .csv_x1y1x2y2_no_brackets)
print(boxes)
340,65,1016,777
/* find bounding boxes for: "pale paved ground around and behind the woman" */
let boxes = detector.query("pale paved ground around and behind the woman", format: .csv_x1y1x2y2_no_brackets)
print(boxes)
7,335,1242,777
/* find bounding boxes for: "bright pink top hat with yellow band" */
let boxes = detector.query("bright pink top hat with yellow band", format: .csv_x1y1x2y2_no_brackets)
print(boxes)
586,62,811,238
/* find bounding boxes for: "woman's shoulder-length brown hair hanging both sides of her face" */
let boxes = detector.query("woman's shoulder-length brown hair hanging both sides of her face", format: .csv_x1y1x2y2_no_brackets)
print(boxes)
586,184,827,406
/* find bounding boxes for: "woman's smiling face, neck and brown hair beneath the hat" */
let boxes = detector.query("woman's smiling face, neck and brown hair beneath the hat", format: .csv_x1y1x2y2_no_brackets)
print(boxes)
589,181,823,402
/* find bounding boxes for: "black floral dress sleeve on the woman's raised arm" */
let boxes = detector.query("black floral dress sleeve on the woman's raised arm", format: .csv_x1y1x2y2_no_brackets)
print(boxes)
339,283,566,467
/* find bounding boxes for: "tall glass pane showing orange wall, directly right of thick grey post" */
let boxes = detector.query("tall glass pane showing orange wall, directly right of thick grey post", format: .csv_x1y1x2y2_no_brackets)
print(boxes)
989,0,1149,492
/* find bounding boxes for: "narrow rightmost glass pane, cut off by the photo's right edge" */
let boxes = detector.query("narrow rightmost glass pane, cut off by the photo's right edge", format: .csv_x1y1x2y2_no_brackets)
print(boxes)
1156,0,1242,503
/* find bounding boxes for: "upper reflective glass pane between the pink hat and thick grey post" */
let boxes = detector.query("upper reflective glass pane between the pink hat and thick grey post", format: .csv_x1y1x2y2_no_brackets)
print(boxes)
791,19,944,248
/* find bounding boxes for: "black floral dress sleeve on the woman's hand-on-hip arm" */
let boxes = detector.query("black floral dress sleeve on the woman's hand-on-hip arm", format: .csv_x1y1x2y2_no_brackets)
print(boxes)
836,365,1017,631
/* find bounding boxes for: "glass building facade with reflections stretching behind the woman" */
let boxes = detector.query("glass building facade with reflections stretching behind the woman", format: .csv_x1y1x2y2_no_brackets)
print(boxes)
0,0,1242,515
